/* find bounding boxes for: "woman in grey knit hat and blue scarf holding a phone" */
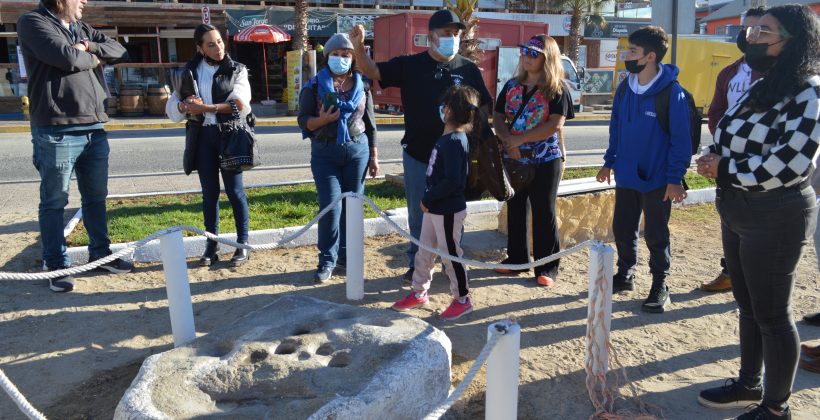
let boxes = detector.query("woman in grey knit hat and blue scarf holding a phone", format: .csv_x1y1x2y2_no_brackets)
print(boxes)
298,33,379,282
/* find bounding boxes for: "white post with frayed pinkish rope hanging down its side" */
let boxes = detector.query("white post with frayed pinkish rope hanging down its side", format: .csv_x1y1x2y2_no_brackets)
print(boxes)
586,243,615,375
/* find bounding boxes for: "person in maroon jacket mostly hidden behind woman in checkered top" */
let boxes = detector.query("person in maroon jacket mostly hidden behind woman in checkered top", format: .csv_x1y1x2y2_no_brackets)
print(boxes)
700,6,766,292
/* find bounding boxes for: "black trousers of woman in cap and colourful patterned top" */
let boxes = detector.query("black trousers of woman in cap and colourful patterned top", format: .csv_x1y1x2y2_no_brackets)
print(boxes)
507,159,561,277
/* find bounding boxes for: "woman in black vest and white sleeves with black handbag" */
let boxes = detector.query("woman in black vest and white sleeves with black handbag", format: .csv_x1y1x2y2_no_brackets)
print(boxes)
165,24,251,266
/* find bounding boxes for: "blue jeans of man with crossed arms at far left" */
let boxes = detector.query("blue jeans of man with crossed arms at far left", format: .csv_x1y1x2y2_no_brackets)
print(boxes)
31,127,111,269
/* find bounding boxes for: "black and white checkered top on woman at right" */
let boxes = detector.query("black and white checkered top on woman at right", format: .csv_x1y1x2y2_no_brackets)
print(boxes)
713,75,820,191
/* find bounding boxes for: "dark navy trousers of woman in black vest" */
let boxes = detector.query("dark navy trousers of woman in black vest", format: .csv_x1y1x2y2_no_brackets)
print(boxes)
196,125,250,243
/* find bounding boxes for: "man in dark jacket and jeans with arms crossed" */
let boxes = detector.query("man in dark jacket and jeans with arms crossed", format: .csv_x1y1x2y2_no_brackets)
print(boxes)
17,0,133,292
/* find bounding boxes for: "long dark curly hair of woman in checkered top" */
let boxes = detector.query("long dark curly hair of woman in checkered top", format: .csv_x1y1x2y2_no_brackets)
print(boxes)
749,4,820,112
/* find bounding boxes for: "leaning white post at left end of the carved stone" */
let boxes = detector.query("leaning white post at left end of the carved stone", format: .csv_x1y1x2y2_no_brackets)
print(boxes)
159,230,196,347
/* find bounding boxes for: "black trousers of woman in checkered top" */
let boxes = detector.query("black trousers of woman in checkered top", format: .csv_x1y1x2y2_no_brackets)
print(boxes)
716,187,817,410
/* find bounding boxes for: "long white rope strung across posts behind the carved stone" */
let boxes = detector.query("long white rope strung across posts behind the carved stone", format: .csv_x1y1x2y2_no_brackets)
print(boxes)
0,192,596,280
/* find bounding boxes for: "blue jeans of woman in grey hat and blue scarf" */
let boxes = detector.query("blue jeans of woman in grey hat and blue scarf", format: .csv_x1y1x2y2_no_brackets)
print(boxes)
310,134,370,269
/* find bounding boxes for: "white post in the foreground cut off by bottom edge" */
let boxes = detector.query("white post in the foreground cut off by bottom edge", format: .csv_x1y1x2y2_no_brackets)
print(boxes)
484,321,521,420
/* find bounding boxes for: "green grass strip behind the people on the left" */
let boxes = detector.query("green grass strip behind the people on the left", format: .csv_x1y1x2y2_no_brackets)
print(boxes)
67,180,405,246
